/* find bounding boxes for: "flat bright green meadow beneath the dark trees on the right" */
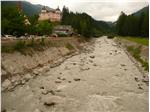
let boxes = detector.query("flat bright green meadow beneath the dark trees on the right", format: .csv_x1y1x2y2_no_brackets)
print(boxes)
121,37,149,46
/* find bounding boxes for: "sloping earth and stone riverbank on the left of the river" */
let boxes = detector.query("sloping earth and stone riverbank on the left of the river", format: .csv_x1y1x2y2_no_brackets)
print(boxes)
2,38,86,91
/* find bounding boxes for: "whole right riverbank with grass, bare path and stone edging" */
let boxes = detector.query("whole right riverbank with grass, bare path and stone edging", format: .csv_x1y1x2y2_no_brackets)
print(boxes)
115,37,149,72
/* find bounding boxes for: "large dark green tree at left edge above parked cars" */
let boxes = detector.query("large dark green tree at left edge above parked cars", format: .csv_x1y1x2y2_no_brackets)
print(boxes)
1,6,26,36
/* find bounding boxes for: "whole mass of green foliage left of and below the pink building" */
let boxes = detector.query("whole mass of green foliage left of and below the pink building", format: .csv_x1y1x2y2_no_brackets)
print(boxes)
1,2,53,36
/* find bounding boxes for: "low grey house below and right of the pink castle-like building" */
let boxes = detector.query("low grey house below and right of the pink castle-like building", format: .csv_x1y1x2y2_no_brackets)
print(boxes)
53,25,74,36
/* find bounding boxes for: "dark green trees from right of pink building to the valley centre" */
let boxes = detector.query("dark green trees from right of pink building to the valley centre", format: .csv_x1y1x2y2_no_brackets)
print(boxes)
61,7,111,38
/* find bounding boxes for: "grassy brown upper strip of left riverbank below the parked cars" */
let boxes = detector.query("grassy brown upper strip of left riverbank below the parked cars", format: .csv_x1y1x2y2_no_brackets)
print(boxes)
1,37,83,54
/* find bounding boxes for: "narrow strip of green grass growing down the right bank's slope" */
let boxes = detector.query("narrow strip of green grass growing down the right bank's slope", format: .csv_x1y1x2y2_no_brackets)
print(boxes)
127,46,149,71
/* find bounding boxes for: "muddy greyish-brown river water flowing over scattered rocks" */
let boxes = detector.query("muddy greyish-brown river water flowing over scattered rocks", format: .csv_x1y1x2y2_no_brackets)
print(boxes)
2,37,148,112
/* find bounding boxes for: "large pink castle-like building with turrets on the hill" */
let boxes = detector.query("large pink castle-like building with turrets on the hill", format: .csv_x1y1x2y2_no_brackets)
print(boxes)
38,6,62,22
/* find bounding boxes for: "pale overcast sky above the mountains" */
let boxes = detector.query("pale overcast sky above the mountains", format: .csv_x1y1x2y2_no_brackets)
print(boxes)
26,0,149,21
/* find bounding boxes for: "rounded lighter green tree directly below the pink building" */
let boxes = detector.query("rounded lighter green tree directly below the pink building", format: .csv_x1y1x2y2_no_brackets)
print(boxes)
36,21,53,35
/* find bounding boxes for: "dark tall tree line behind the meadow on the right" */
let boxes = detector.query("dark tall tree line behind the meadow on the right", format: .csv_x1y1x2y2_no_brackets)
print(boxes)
116,11,149,37
